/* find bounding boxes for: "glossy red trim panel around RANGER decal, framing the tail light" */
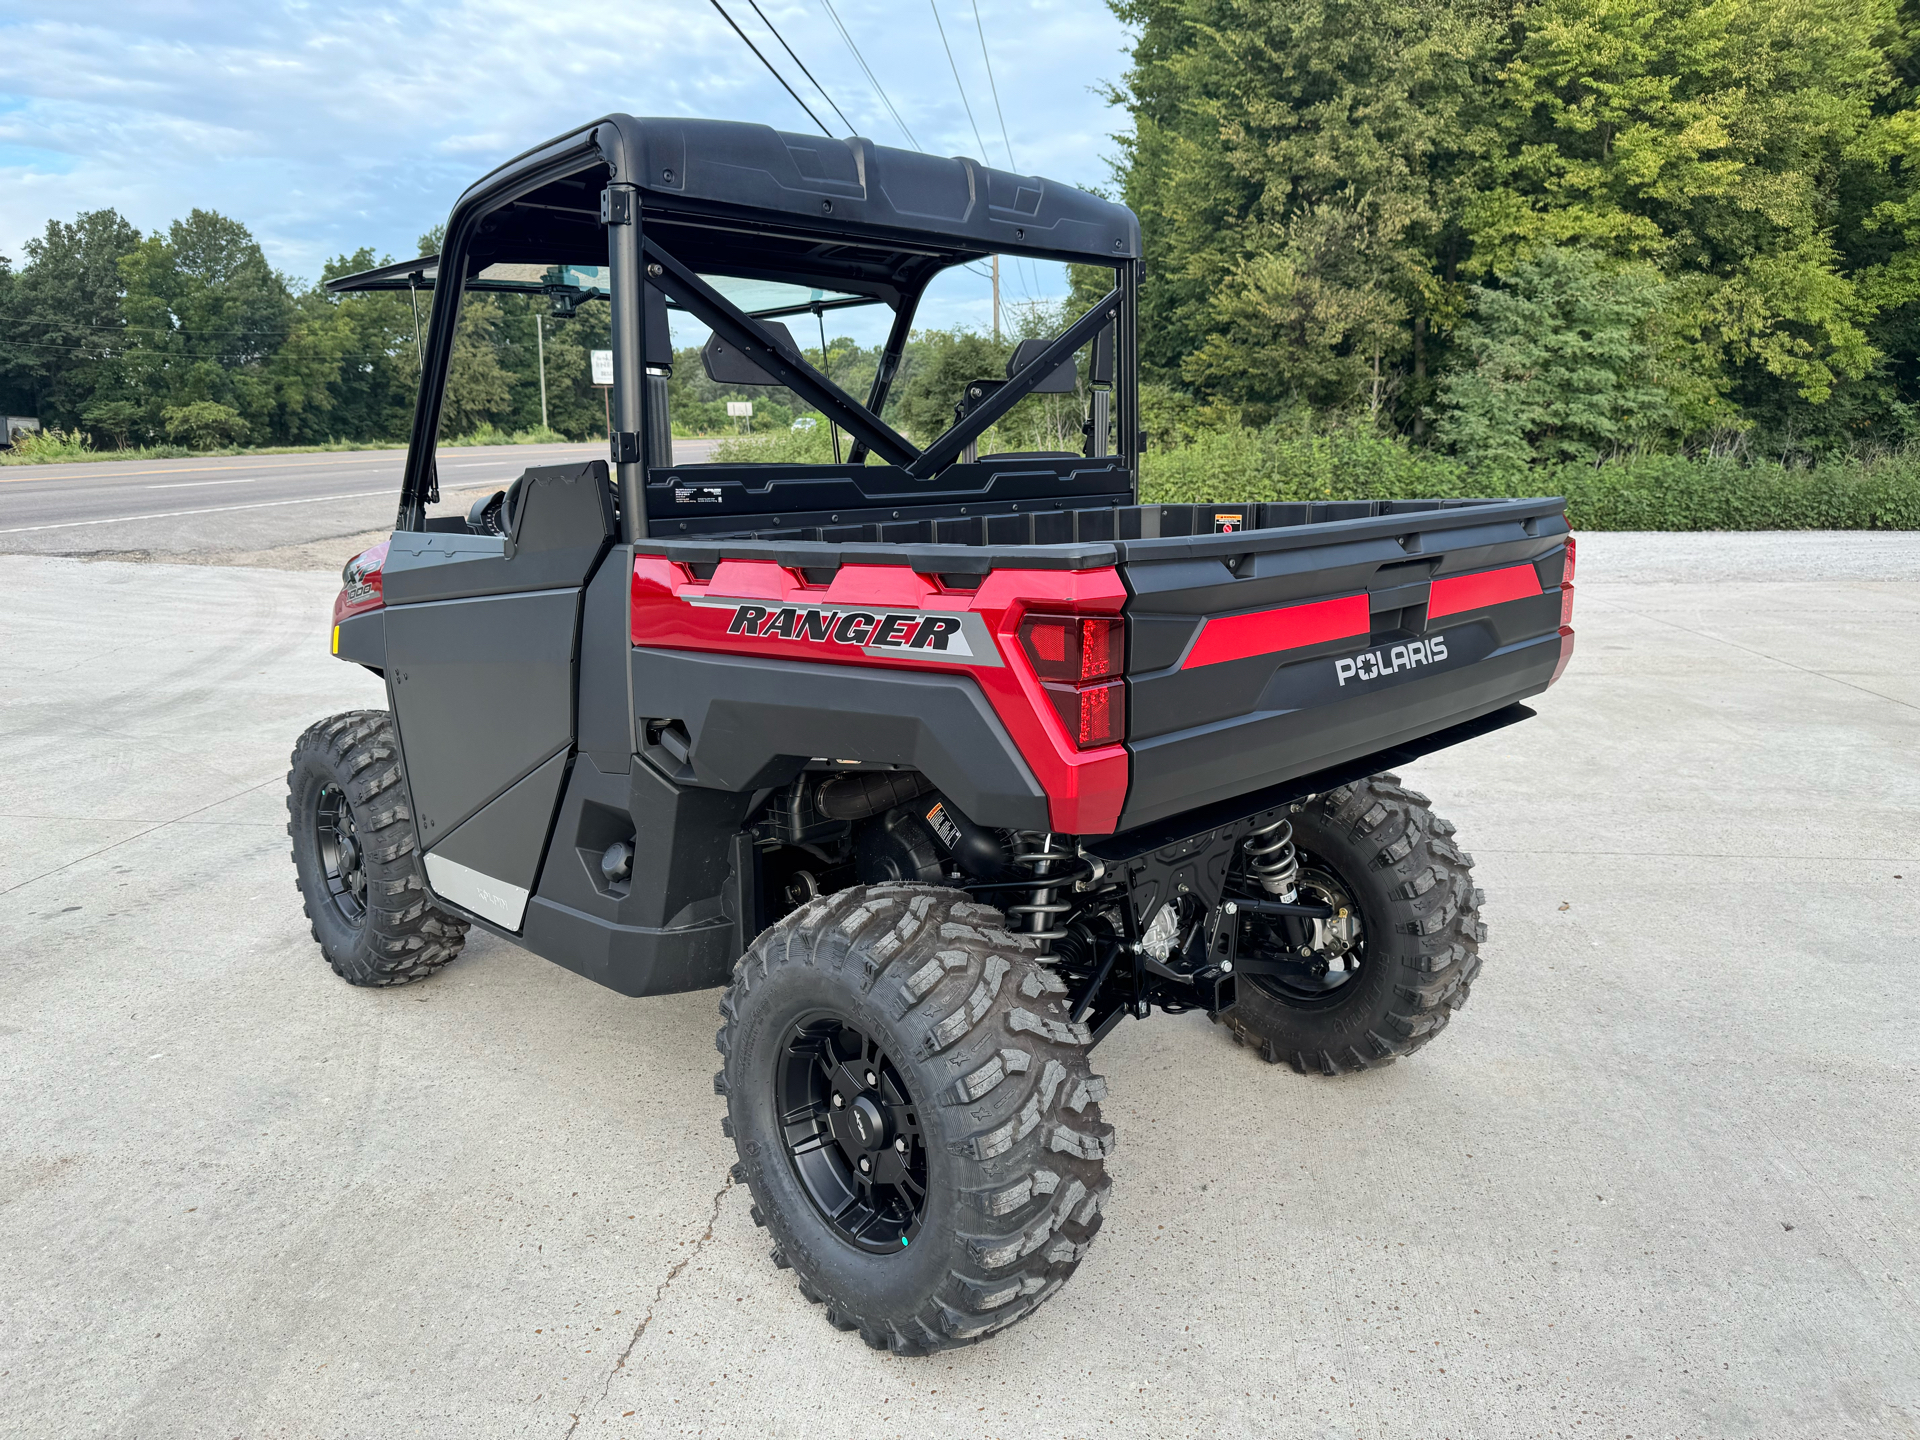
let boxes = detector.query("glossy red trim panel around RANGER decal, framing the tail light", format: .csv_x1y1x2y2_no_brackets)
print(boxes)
632,555,1128,836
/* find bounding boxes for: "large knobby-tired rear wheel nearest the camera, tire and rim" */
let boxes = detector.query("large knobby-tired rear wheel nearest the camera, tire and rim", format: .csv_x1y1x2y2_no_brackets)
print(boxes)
715,884,1114,1355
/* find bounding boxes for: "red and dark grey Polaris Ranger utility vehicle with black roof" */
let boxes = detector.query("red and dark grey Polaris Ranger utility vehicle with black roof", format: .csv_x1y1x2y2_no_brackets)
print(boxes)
288,115,1573,1355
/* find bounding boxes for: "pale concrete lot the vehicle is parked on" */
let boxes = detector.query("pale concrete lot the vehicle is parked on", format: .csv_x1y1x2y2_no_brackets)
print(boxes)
0,534,1921,1437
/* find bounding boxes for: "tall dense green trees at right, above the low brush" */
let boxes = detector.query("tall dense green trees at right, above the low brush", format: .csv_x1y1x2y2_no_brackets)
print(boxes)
1110,0,1917,451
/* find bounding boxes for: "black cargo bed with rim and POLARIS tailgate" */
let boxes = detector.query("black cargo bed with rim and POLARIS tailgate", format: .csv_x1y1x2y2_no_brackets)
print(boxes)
634,498,1573,830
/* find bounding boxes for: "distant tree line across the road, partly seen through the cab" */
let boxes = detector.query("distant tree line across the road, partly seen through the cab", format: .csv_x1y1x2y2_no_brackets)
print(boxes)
0,209,1114,450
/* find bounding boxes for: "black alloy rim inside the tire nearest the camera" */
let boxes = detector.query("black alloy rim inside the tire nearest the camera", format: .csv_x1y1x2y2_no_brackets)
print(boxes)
774,1014,928,1255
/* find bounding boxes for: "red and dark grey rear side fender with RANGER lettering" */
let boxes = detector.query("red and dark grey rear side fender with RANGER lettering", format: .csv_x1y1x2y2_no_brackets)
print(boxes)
632,555,1128,836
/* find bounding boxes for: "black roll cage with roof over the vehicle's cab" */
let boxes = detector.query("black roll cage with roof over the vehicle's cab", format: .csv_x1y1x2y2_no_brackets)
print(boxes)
328,115,1141,542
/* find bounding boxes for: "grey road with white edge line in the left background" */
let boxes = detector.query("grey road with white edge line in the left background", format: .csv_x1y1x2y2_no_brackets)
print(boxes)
0,440,715,559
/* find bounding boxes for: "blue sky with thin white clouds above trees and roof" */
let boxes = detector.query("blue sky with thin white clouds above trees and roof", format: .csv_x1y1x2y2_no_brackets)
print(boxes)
0,0,1128,338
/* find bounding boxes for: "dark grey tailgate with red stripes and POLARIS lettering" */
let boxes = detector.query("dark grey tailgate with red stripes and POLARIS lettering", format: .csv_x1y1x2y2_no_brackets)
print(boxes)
1120,500,1573,828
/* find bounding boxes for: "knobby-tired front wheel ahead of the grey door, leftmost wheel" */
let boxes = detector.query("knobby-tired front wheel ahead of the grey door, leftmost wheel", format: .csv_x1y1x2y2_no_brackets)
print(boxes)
286,711,467,986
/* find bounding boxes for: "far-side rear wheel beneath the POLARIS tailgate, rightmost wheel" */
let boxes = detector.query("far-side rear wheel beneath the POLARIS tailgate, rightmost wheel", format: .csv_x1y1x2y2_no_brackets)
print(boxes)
1216,774,1487,1076
